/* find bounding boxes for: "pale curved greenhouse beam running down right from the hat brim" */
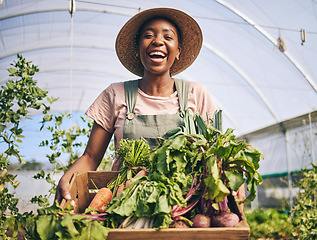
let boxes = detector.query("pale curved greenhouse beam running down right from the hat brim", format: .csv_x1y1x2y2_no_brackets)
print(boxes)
203,42,279,122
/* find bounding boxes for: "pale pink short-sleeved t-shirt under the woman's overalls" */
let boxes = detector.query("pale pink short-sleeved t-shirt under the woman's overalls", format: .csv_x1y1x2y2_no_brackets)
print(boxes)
86,79,217,151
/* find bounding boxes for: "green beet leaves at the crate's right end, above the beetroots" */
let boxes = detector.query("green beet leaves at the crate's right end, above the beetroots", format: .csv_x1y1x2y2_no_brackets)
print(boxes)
205,126,264,202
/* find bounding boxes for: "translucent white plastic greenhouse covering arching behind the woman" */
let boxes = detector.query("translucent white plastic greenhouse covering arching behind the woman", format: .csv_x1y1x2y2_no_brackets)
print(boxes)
0,0,317,182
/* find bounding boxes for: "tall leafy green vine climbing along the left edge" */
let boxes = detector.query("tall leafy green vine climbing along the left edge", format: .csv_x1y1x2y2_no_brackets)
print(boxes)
0,54,56,239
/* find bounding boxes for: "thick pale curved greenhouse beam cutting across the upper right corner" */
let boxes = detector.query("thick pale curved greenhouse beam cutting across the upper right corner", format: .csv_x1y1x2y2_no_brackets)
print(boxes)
215,0,317,93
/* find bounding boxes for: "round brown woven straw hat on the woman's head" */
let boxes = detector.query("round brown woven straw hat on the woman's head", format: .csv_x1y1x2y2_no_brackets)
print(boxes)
116,8,203,76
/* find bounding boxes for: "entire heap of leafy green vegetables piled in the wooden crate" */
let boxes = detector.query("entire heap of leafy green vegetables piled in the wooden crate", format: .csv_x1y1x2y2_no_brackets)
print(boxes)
30,112,263,236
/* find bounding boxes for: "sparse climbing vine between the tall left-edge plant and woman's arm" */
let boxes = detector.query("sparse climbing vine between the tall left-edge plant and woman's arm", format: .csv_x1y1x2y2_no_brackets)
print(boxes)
31,112,113,207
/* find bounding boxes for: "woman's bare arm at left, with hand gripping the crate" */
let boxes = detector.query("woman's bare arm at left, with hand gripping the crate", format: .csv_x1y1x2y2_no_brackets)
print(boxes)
55,122,112,203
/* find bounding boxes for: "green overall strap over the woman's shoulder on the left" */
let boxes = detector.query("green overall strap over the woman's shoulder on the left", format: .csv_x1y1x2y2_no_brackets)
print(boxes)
124,80,139,114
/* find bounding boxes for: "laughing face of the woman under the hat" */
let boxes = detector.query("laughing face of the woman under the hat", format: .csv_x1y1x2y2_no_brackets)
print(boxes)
139,18,180,75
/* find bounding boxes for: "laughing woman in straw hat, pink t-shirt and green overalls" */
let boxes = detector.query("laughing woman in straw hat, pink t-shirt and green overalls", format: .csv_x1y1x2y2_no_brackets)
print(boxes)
56,8,232,206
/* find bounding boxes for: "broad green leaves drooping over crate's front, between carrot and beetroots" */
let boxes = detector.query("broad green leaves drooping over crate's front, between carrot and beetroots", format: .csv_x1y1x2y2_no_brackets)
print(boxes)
106,176,184,228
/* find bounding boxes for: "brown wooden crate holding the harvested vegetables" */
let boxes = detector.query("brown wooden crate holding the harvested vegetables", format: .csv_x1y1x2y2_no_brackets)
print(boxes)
61,171,250,240
